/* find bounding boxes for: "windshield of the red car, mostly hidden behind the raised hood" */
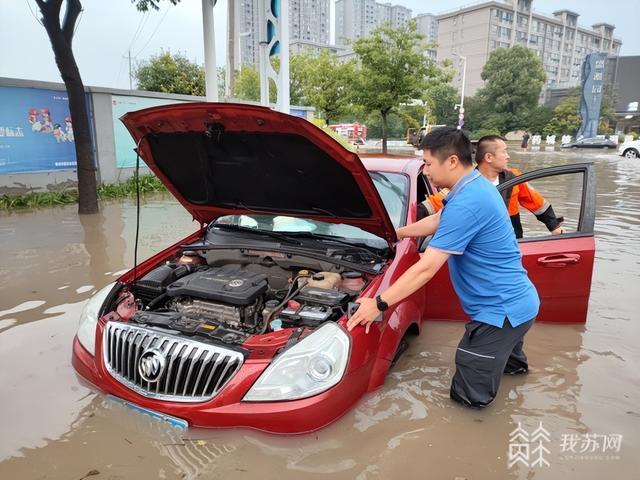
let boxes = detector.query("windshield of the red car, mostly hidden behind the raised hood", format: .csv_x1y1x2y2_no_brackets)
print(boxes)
214,172,409,247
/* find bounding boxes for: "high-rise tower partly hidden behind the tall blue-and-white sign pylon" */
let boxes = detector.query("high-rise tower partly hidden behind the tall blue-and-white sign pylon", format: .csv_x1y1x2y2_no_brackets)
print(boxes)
235,0,330,69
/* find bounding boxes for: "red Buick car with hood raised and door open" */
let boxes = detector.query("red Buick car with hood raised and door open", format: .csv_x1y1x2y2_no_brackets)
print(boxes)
73,103,595,433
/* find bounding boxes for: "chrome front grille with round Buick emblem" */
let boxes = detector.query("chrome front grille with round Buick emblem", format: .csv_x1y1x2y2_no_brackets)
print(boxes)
102,322,244,402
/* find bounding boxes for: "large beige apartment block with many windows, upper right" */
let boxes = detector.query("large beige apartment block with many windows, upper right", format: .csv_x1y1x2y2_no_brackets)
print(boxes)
437,0,622,95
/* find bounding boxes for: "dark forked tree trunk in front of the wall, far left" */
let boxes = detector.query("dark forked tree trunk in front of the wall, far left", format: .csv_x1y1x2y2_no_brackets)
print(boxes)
36,0,98,214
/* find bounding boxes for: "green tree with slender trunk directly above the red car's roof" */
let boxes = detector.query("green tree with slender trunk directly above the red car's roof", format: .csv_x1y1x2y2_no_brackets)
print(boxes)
353,21,437,153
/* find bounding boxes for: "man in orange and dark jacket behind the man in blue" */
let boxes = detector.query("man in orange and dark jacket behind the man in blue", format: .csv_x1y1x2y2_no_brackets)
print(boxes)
418,135,564,238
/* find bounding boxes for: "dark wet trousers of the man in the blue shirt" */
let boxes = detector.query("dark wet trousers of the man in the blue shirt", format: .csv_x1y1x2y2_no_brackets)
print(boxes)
451,318,535,408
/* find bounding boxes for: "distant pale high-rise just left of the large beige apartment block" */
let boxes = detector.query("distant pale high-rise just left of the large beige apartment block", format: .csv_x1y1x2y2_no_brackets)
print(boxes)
335,0,411,45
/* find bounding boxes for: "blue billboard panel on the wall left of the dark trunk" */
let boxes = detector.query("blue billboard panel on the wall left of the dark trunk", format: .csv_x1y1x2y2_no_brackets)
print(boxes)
0,87,76,175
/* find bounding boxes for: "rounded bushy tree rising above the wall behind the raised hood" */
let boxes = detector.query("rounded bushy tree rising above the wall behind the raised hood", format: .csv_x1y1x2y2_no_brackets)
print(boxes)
135,52,205,95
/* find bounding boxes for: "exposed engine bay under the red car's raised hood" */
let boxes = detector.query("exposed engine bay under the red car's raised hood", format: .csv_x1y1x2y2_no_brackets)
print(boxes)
106,250,369,345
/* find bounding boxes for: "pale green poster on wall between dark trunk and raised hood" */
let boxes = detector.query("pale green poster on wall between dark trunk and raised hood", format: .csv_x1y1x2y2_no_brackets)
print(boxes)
111,95,184,168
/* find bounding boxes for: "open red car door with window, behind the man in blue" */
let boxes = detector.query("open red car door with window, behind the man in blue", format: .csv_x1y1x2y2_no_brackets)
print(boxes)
424,163,596,323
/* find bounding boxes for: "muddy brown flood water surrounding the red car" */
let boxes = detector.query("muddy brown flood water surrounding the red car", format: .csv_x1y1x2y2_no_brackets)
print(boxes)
0,151,640,480
